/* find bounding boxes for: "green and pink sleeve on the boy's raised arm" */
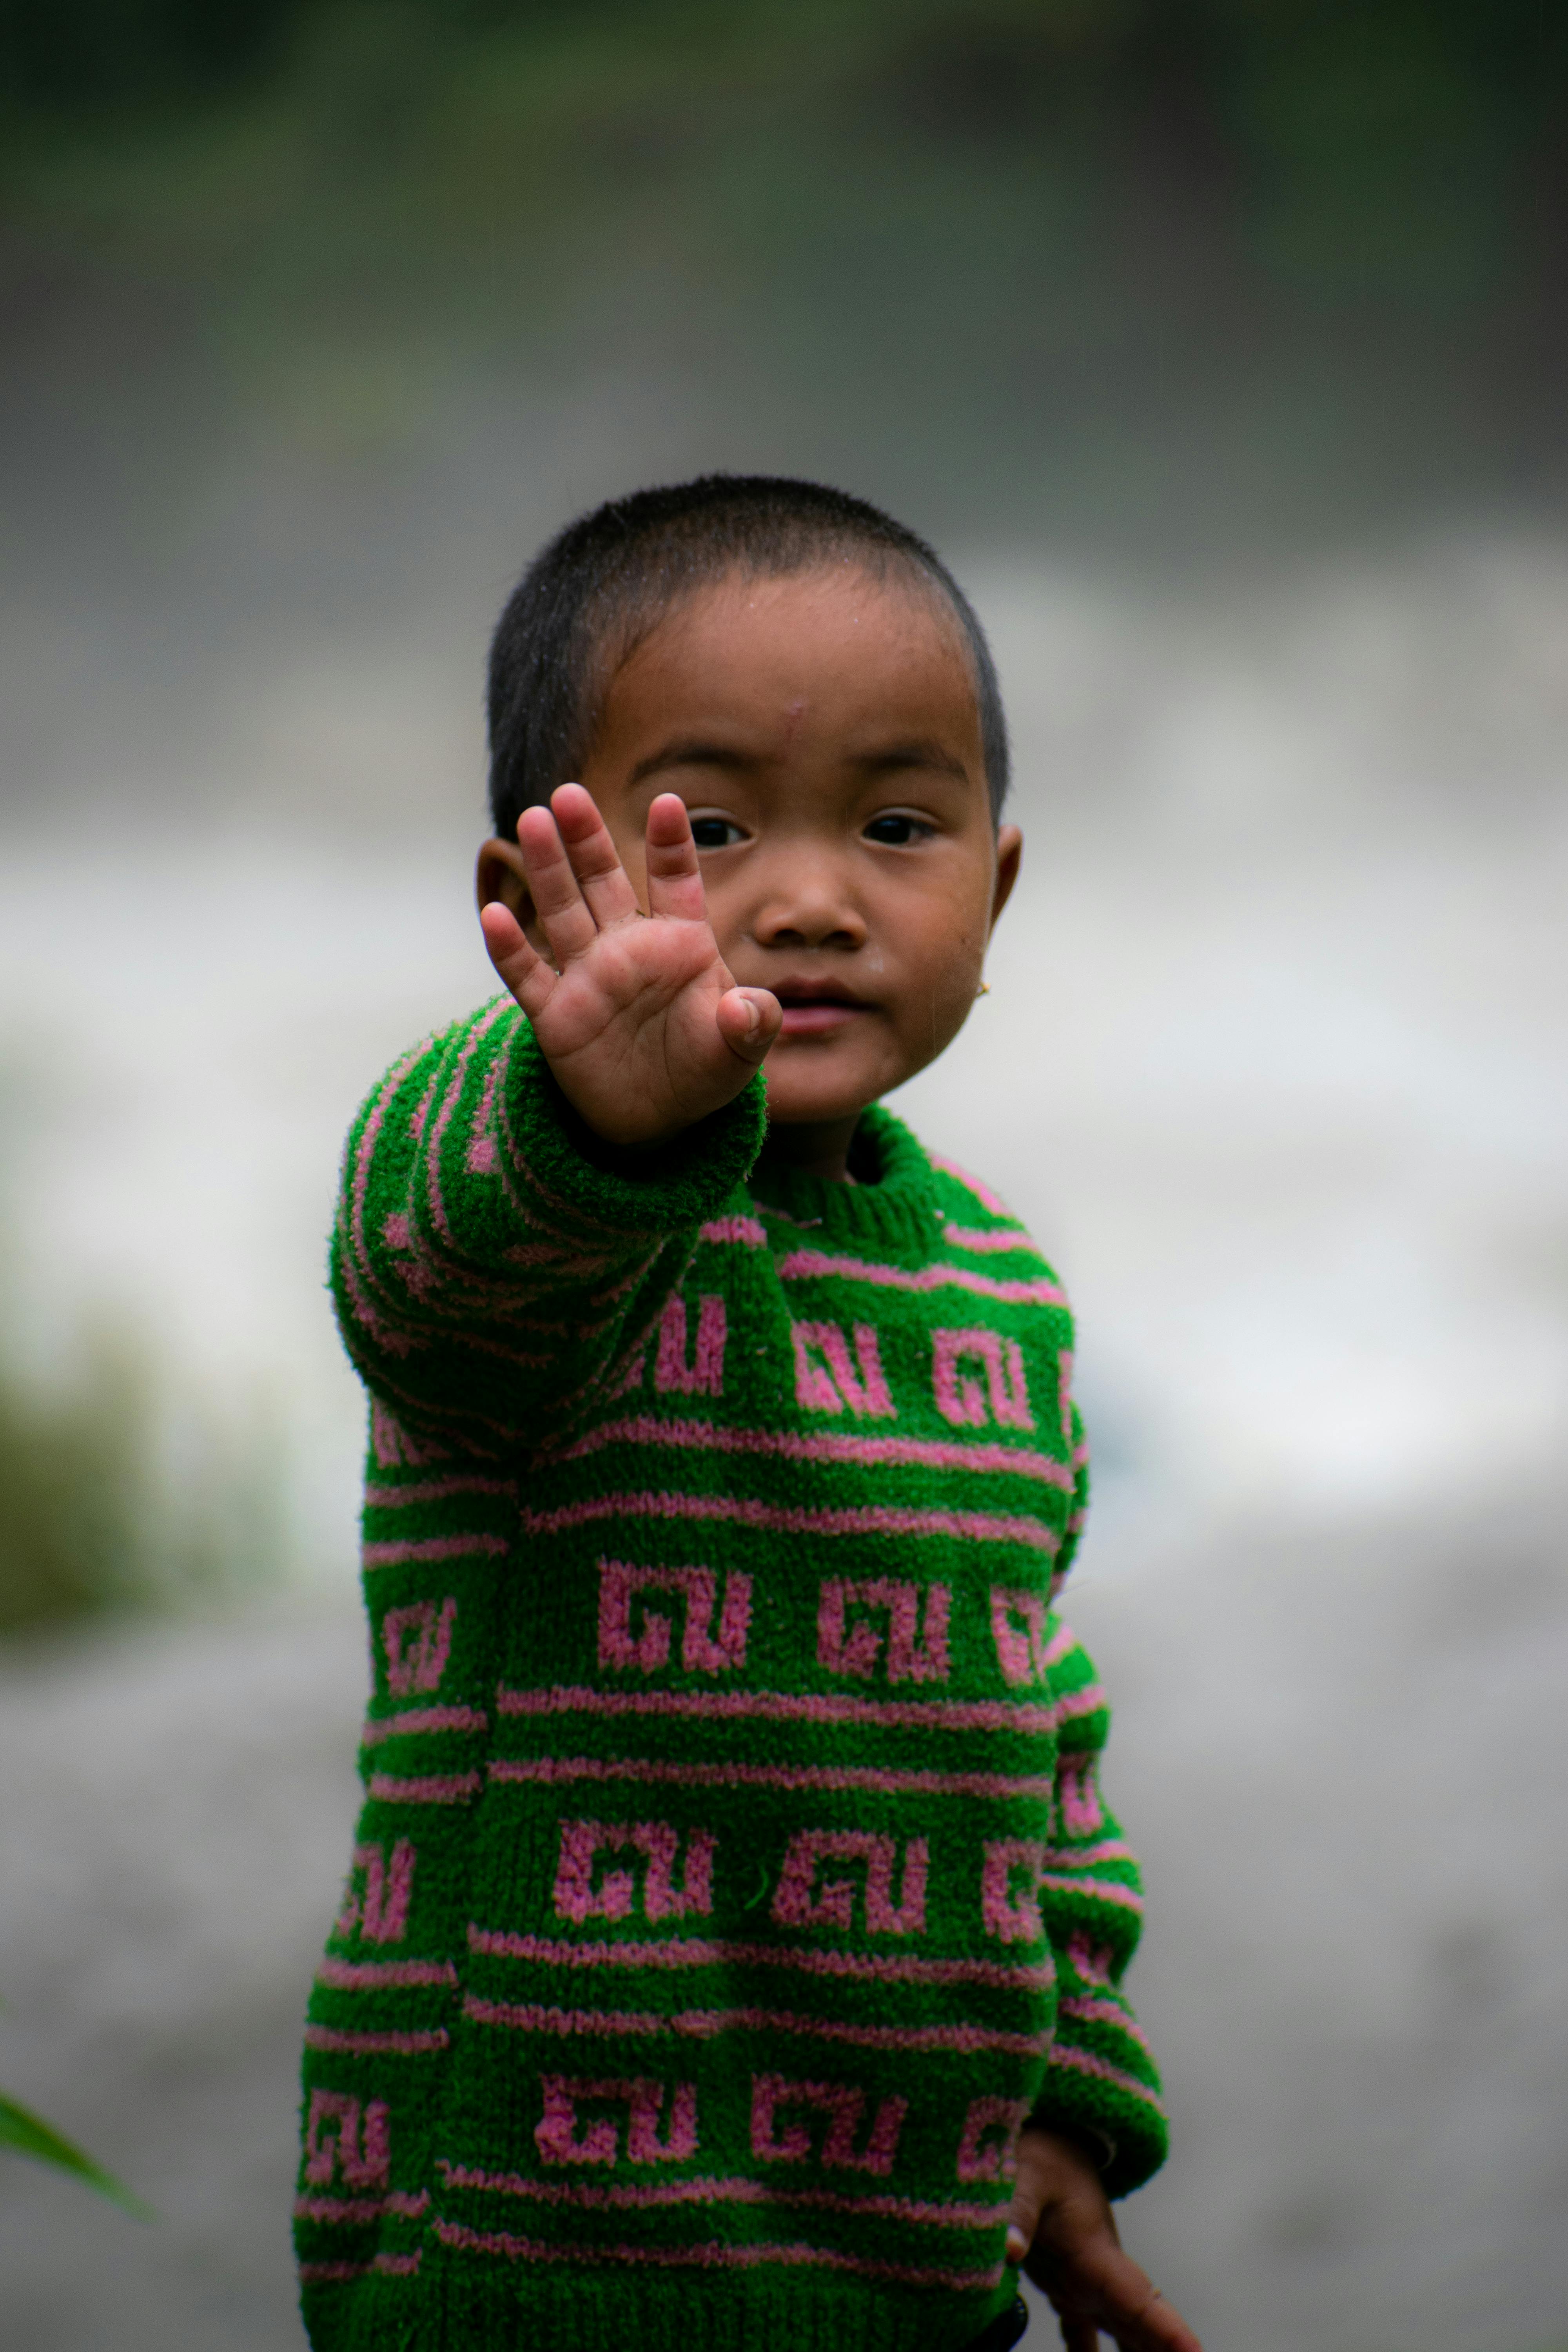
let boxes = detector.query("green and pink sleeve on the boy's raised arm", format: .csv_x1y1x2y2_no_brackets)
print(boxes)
332,997,764,1458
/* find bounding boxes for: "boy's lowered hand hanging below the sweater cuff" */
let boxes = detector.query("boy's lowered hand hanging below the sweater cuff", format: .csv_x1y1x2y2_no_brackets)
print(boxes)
1006,2129,1201,2352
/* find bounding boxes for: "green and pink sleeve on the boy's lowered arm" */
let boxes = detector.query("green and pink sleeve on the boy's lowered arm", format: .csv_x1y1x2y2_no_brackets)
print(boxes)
1032,1621,1169,2197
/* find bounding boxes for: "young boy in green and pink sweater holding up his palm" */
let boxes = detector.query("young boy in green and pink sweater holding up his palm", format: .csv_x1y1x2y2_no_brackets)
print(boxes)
296,477,1196,2352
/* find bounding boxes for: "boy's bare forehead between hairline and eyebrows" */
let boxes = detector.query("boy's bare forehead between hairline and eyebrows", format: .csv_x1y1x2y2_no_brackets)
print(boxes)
602,562,980,753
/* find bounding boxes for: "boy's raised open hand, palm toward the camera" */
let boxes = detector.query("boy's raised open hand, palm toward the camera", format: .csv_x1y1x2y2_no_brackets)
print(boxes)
479,783,783,1145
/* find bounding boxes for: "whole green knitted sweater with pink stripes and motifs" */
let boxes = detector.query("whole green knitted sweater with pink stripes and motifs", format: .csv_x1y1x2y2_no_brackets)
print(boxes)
296,1000,1166,2352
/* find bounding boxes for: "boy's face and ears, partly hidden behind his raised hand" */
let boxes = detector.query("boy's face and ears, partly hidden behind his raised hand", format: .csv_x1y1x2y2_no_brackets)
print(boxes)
479,567,1023,1127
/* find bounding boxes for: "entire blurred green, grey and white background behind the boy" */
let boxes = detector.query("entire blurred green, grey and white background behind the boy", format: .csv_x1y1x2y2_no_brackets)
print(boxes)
0,0,1568,2352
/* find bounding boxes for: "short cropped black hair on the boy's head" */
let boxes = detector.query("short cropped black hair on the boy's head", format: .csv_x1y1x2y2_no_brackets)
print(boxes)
486,473,1009,842
